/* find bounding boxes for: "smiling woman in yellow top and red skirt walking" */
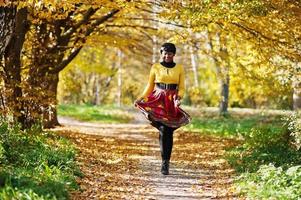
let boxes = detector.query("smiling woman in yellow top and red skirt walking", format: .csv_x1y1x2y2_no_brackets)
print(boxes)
135,43,191,175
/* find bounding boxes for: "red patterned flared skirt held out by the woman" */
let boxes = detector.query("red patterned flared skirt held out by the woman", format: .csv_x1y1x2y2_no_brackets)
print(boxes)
135,88,191,128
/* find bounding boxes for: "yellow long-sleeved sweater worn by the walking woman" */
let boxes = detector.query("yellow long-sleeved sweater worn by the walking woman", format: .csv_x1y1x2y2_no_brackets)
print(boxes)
142,63,185,99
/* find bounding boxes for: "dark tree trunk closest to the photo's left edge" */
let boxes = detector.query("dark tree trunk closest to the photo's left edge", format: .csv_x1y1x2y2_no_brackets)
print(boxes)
4,8,29,127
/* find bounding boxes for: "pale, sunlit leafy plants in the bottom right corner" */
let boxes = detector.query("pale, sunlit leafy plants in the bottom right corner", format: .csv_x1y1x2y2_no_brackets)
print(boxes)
238,164,301,200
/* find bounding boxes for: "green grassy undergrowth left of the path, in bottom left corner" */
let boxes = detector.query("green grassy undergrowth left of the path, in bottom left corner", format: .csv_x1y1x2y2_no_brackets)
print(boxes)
0,122,81,199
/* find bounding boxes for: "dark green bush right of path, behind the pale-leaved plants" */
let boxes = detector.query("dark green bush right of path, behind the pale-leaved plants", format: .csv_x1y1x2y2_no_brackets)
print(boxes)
228,120,301,173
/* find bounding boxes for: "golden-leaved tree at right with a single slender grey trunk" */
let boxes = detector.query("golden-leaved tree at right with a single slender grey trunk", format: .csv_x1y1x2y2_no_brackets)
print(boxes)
158,0,301,112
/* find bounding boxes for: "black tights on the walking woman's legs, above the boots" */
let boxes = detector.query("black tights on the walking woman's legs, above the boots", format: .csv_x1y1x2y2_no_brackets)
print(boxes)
152,122,175,161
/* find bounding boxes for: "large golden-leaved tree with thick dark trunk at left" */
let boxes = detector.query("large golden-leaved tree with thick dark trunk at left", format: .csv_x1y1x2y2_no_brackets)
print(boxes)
0,0,159,127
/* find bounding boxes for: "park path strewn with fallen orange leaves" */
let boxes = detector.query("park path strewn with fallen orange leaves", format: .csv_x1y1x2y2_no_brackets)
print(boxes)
55,113,239,200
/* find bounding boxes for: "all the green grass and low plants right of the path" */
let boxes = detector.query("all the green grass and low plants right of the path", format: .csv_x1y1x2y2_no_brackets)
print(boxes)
184,112,301,199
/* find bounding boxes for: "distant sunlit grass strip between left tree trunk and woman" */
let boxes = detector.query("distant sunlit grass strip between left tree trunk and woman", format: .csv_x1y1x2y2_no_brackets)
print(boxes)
58,105,132,123
